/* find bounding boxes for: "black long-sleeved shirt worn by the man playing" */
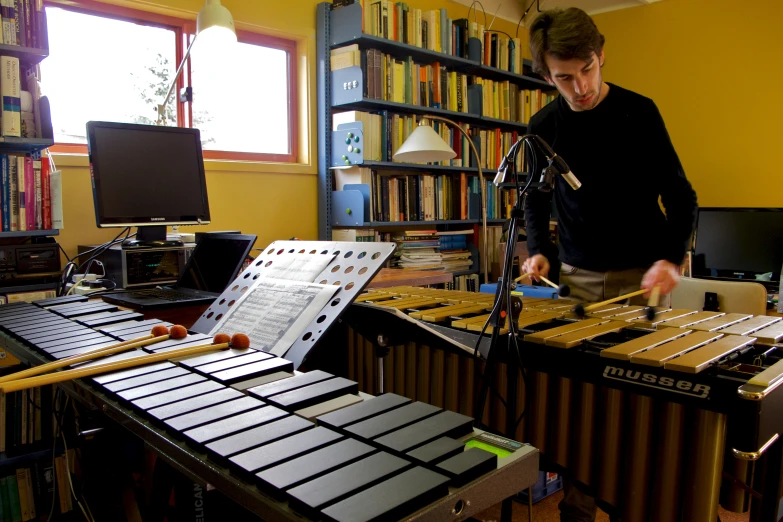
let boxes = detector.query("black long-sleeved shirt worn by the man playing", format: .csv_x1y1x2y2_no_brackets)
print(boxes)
525,84,697,271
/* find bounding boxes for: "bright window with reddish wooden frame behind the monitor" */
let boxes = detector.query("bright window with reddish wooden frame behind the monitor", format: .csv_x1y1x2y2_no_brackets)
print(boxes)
41,4,297,162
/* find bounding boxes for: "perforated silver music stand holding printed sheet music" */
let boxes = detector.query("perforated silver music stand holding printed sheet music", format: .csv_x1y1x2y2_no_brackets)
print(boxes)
191,241,395,368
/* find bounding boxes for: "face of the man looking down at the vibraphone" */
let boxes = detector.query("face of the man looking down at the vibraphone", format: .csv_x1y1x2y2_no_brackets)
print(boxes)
544,51,604,111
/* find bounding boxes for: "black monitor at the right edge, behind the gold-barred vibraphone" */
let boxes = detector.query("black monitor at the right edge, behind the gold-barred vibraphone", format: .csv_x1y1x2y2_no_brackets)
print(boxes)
693,208,783,282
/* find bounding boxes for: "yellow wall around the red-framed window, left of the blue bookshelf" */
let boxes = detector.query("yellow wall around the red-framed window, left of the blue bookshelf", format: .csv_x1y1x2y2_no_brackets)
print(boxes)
55,0,526,255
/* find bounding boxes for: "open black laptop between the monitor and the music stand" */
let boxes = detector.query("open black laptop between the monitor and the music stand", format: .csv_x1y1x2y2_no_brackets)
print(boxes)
103,234,257,310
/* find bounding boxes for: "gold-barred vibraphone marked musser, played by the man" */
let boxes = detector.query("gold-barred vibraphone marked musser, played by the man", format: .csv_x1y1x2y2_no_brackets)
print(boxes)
344,287,783,522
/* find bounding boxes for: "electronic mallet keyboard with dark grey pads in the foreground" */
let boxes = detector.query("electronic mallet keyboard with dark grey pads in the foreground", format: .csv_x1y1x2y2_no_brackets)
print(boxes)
0,296,538,520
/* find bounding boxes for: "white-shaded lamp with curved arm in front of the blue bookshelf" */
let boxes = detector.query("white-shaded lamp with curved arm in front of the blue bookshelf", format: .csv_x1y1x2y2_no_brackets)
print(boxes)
393,115,489,283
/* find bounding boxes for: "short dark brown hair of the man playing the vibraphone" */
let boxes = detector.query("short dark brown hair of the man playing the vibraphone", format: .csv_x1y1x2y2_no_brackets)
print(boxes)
530,7,604,76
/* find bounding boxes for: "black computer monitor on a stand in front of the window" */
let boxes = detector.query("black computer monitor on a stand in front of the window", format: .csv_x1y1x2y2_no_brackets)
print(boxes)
87,121,210,246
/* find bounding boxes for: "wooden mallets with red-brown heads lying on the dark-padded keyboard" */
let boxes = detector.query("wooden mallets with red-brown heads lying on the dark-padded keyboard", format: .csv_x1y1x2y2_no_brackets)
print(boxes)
0,325,250,393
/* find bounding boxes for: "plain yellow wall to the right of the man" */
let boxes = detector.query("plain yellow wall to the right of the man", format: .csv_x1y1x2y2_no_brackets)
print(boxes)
594,0,783,207
